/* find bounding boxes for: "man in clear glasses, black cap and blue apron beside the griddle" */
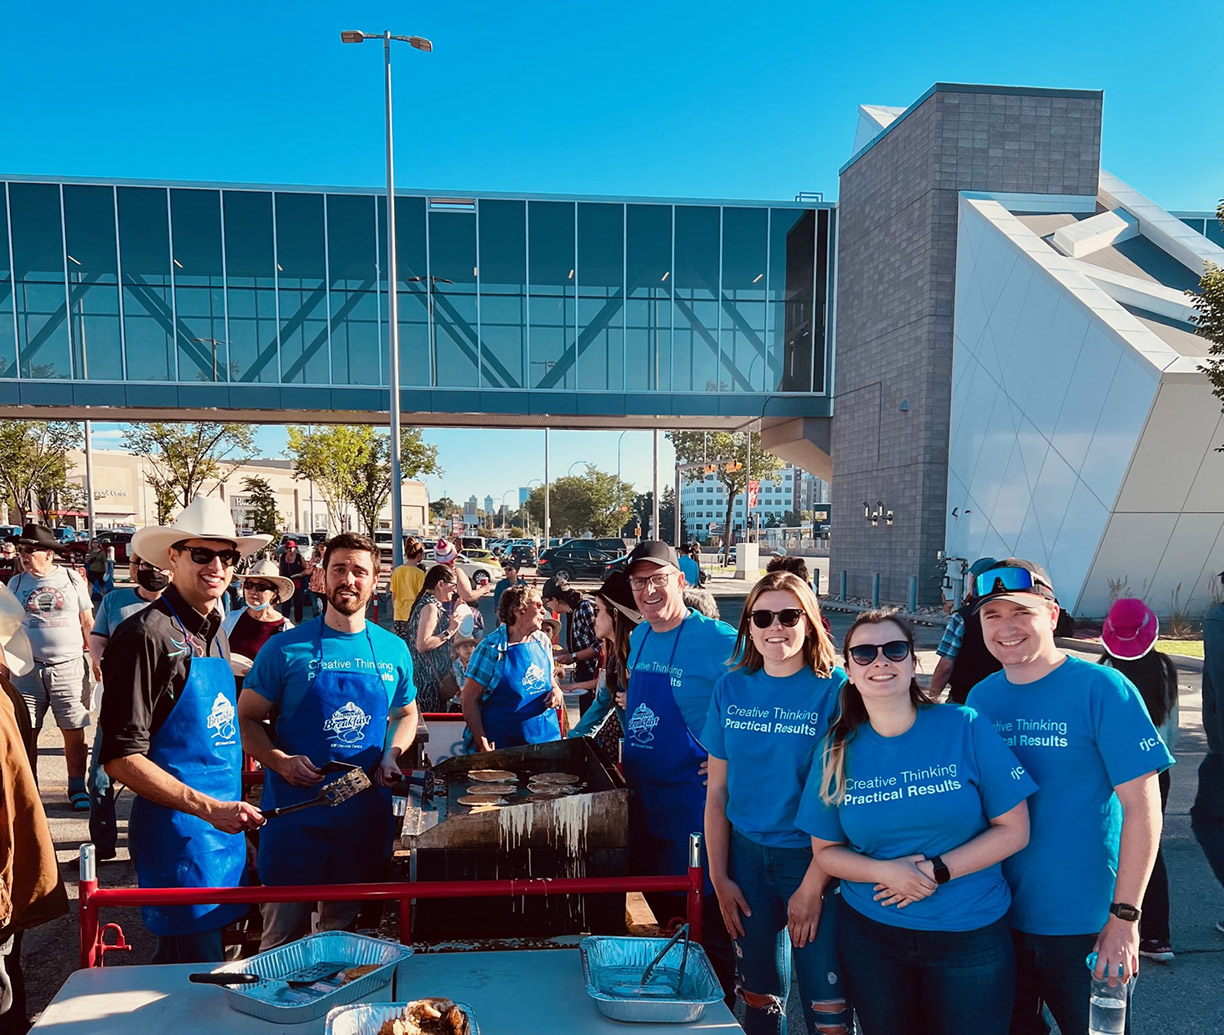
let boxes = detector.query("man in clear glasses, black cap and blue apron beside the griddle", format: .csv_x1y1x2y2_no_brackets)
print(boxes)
624,540,736,995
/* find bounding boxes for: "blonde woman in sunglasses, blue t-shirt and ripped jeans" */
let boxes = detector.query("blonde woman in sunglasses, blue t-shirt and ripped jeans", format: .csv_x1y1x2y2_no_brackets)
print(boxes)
701,571,851,1035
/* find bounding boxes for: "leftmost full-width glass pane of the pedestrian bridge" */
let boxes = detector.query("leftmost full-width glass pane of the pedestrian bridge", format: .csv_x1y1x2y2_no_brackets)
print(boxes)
9,184,72,378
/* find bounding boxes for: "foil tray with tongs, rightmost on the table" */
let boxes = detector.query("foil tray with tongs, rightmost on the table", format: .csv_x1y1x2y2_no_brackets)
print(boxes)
578,937,722,1024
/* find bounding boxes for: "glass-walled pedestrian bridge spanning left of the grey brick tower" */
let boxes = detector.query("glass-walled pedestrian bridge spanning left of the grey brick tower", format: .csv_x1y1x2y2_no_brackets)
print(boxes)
0,177,835,428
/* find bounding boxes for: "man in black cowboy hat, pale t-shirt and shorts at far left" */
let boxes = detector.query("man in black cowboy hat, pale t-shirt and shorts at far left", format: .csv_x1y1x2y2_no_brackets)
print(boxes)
9,525,93,812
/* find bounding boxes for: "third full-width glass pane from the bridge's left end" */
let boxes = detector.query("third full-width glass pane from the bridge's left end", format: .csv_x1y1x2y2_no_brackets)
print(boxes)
118,187,176,380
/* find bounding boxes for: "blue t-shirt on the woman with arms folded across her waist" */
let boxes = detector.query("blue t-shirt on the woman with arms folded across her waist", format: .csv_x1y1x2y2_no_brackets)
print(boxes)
797,705,1037,931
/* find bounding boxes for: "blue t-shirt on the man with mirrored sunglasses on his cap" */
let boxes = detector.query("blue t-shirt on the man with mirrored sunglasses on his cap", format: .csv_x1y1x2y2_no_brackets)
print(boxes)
969,657,1173,935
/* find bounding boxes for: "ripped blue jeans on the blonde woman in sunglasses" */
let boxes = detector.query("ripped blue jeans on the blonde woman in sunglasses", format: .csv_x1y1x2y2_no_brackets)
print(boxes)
727,829,851,1035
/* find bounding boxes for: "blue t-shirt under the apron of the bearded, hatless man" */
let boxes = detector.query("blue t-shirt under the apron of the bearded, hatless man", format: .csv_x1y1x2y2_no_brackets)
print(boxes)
242,618,416,716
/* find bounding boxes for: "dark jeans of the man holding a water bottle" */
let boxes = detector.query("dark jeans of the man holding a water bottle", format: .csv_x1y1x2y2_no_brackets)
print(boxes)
1011,931,1135,1035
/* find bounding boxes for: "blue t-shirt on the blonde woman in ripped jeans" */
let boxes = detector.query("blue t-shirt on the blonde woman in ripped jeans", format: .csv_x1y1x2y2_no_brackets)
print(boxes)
701,668,846,848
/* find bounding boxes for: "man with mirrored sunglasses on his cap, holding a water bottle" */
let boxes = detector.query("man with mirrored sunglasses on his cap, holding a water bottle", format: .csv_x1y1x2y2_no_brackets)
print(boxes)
968,558,1173,1035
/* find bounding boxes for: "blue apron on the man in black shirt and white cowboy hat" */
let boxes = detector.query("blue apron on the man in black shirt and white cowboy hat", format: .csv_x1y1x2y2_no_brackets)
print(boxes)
129,601,250,937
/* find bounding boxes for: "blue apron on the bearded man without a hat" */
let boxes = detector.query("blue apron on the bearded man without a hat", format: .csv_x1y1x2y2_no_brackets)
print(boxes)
258,618,395,885
